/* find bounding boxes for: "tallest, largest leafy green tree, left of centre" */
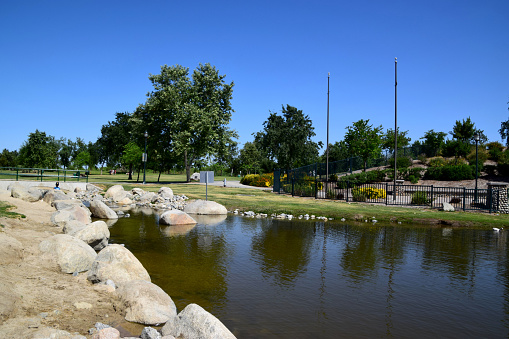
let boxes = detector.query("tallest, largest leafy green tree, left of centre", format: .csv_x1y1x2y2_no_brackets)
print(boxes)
135,64,237,181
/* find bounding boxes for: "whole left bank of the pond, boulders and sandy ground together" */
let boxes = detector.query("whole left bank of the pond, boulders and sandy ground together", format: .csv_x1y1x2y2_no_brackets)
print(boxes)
0,182,235,339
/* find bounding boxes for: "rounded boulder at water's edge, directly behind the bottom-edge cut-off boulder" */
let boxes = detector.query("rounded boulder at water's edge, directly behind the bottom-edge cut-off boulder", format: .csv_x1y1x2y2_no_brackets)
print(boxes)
117,280,177,325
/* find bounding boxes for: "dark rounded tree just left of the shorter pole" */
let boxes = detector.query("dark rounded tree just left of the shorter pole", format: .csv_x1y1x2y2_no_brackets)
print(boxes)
255,105,322,169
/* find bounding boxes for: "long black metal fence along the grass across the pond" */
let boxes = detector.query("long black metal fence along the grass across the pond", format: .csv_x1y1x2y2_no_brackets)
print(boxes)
274,175,507,213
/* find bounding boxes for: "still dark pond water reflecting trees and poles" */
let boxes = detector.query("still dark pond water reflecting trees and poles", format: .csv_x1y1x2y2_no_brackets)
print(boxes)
110,209,509,338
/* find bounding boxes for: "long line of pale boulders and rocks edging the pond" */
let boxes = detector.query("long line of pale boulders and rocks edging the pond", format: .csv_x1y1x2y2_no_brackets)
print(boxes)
4,184,235,339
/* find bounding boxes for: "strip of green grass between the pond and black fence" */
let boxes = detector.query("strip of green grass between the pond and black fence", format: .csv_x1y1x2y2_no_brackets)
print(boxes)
97,184,509,227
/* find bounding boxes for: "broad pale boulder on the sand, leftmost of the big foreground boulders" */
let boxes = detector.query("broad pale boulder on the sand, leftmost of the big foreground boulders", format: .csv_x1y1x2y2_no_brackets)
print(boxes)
39,234,97,273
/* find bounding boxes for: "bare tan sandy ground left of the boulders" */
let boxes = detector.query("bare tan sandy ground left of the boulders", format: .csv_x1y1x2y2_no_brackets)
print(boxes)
0,191,137,338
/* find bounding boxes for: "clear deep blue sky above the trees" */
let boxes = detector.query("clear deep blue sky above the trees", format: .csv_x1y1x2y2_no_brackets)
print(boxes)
0,0,509,150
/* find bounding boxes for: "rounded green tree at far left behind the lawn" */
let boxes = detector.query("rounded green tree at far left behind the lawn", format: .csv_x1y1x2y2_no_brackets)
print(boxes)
19,129,59,168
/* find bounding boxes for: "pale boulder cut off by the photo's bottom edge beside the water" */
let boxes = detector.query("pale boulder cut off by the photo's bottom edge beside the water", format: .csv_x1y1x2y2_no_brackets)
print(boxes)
161,304,235,339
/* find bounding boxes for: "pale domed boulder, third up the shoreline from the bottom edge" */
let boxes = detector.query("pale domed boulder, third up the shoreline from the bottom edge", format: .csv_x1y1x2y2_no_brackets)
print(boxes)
87,244,150,285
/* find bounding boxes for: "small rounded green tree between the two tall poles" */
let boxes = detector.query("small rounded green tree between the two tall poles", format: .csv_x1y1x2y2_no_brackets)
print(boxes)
345,119,383,172
